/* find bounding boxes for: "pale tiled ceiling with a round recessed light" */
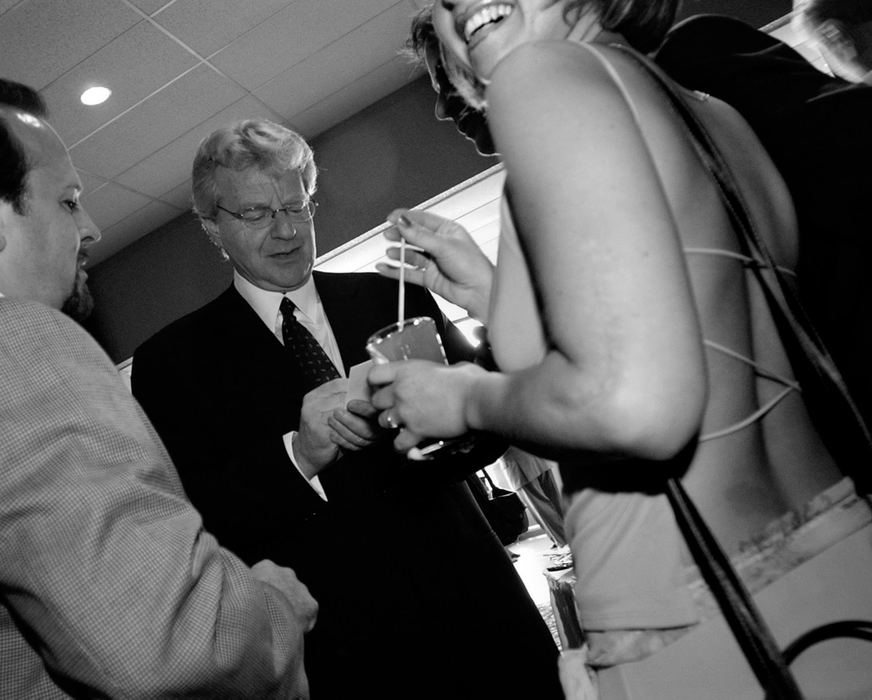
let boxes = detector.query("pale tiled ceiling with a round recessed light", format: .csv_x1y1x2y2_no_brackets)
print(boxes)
0,0,424,264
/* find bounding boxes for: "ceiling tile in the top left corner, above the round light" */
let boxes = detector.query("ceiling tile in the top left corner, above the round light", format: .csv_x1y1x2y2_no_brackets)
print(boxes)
0,0,141,90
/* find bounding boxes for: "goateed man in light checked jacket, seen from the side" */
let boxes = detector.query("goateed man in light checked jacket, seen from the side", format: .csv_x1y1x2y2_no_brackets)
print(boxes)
0,80,317,700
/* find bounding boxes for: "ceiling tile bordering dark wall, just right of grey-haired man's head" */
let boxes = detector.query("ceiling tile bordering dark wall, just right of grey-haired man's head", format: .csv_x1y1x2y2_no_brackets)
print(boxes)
288,56,420,139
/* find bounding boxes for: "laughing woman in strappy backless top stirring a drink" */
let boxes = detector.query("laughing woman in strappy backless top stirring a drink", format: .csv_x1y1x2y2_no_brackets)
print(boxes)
369,0,870,699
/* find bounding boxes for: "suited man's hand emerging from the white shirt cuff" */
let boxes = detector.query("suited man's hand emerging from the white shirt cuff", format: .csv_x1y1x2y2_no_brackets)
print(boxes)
293,378,348,479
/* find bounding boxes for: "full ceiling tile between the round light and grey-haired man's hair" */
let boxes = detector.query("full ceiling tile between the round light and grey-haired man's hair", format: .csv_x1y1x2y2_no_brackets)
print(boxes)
70,64,245,179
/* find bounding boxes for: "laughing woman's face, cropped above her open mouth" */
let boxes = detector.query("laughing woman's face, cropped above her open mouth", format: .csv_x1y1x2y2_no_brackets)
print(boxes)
433,0,572,82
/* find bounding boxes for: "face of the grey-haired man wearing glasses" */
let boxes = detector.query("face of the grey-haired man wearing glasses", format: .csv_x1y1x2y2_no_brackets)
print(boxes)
209,167,315,292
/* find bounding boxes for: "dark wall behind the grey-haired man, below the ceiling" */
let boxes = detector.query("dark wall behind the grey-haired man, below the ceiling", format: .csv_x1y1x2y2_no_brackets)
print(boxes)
87,78,496,362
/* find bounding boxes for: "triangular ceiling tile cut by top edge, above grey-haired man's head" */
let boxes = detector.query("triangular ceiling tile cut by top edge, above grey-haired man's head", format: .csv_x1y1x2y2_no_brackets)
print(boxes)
154,0,293,56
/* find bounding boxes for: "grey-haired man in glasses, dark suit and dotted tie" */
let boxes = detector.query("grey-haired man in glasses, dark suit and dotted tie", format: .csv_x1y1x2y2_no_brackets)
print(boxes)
132,120,561,699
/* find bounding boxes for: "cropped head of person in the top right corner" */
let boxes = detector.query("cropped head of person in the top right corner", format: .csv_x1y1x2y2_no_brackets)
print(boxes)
793,0,872,85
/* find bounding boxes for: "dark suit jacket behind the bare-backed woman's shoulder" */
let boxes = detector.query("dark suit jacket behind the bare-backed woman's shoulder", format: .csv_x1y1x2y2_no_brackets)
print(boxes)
656,15,872,460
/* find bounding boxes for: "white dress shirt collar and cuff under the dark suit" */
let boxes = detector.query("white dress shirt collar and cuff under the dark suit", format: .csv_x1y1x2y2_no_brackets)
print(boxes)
233,270,345,501
